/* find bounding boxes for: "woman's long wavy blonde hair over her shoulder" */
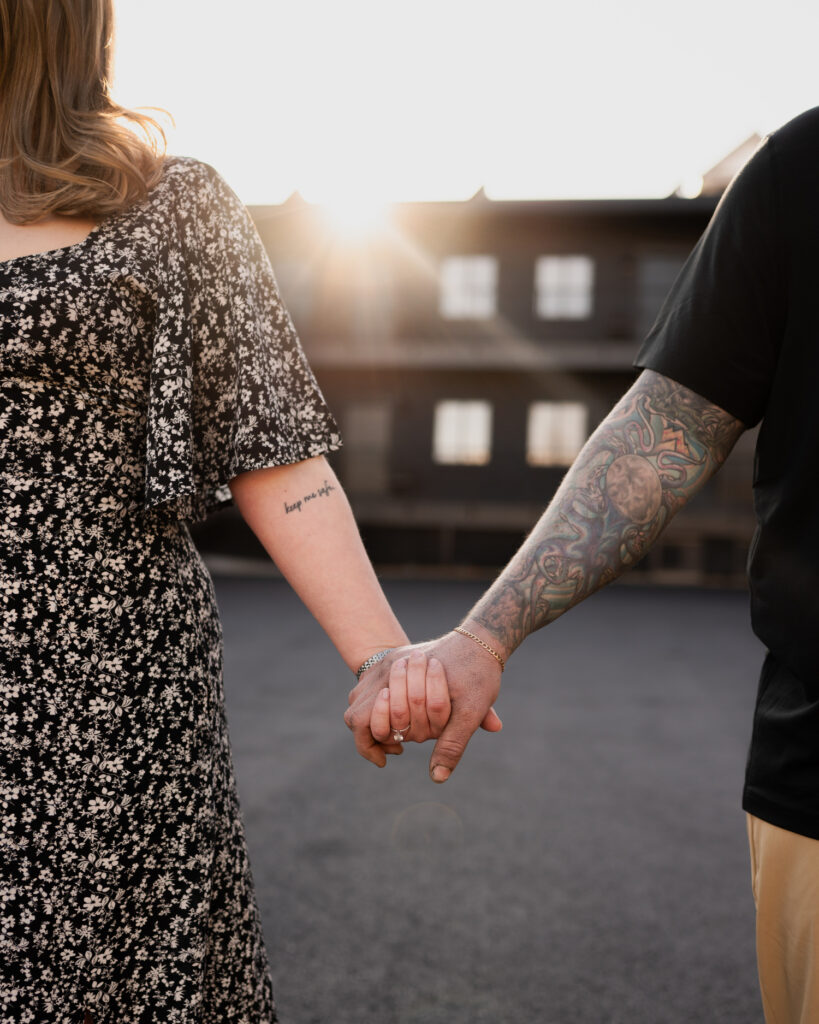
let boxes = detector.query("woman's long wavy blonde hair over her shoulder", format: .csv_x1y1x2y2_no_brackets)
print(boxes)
0,0,172,224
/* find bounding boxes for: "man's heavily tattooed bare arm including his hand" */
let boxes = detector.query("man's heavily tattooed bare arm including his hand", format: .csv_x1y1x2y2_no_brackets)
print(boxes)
345,370,744,781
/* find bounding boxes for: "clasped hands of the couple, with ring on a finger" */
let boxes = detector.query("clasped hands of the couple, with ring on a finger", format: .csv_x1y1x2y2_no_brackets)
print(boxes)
344,632,502,782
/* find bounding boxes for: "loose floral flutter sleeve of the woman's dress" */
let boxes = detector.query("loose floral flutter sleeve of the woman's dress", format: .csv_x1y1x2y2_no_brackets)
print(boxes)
145,161,341,521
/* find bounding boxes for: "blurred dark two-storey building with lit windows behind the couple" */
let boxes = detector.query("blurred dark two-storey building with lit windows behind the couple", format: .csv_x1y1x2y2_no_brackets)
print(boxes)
190,193,753,585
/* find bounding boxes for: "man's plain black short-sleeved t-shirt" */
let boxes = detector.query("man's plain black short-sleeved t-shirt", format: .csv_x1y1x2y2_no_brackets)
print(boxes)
636,108,819,839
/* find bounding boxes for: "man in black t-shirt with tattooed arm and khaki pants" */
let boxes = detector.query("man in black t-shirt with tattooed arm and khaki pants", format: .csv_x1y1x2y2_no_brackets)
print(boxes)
345,108,819,1024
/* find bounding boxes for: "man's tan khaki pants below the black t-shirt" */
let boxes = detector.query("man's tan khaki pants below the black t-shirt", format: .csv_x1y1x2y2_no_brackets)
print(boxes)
747,814,819,1024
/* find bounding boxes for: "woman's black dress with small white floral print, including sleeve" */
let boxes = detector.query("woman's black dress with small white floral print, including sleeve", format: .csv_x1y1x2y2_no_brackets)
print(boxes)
0,157,339,1024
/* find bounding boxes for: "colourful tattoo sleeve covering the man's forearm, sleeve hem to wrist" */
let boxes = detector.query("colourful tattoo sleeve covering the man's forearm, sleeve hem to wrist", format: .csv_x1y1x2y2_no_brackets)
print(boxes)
468,370,745,653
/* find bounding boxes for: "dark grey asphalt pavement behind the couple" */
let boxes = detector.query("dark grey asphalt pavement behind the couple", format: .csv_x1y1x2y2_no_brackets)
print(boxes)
216,578,762,1024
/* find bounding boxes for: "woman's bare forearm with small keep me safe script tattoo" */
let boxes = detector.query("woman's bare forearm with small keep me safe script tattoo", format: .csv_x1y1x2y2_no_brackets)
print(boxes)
230,457,407,671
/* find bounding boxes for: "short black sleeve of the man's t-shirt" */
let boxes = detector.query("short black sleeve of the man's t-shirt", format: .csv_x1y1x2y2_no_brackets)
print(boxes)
635,137,785,426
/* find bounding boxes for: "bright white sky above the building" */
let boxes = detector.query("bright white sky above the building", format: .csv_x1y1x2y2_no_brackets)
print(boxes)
113,0,819,203
